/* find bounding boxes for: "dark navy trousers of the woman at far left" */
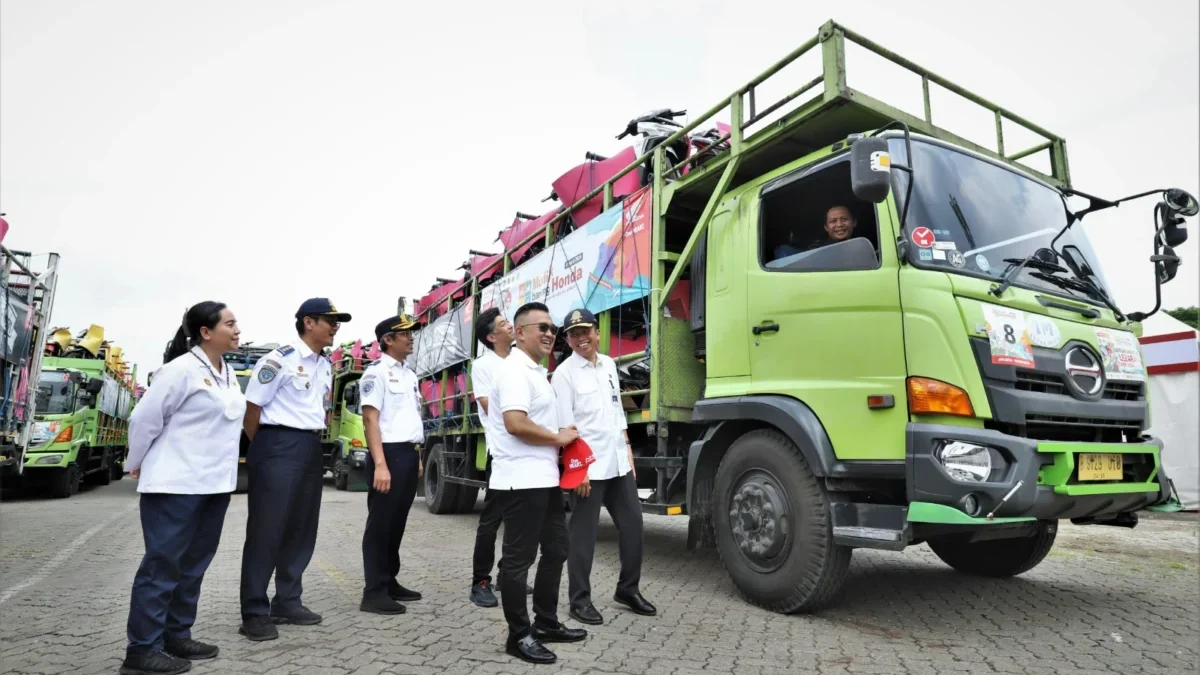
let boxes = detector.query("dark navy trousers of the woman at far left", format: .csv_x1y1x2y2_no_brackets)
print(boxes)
126,492,229,653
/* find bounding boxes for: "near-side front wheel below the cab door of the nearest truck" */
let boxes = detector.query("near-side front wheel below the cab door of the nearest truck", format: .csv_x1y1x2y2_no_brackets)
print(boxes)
713,429,852,614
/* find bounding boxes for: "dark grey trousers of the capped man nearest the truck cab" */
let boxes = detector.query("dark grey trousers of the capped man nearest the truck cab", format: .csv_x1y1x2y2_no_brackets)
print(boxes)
566,472,643,608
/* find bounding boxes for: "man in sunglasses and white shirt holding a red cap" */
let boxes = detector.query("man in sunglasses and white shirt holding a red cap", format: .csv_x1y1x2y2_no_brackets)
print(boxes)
487,303,587,663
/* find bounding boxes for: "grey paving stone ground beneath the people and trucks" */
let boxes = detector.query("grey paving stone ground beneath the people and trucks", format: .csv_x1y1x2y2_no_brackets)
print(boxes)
0,478,1200,675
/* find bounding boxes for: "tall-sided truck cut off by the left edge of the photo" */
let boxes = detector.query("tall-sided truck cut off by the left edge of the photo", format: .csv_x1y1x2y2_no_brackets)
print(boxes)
0,228,59,488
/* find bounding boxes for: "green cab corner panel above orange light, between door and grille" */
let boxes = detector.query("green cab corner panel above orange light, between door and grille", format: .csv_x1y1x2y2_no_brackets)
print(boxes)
900,265,991,419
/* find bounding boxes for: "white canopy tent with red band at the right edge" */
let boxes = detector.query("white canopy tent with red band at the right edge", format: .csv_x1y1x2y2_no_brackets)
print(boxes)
1140,312,1200,510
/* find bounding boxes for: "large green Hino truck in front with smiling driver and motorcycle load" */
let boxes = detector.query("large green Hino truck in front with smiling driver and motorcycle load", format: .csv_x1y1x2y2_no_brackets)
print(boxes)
413,22,1198,613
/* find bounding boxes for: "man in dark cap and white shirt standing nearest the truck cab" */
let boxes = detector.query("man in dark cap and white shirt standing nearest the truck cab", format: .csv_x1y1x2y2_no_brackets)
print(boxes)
553,309,658,625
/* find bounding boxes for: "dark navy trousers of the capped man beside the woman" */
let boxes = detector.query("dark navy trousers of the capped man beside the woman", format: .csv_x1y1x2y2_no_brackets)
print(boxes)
241,426,325,619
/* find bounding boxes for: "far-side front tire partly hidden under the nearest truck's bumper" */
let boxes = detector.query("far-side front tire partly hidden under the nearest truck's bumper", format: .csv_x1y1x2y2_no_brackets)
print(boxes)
928,520,1058,579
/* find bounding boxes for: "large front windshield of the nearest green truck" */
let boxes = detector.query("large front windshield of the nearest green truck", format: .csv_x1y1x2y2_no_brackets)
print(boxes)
889,138,1108,303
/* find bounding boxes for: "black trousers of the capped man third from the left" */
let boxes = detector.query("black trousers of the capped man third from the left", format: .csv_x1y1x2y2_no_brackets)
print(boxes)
362,443,420,598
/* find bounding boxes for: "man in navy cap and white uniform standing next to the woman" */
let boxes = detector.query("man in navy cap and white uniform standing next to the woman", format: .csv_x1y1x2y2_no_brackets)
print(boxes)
239,298,350,641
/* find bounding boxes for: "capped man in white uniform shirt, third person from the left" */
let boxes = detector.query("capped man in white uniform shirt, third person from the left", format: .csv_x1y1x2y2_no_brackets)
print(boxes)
359,316,425,614
